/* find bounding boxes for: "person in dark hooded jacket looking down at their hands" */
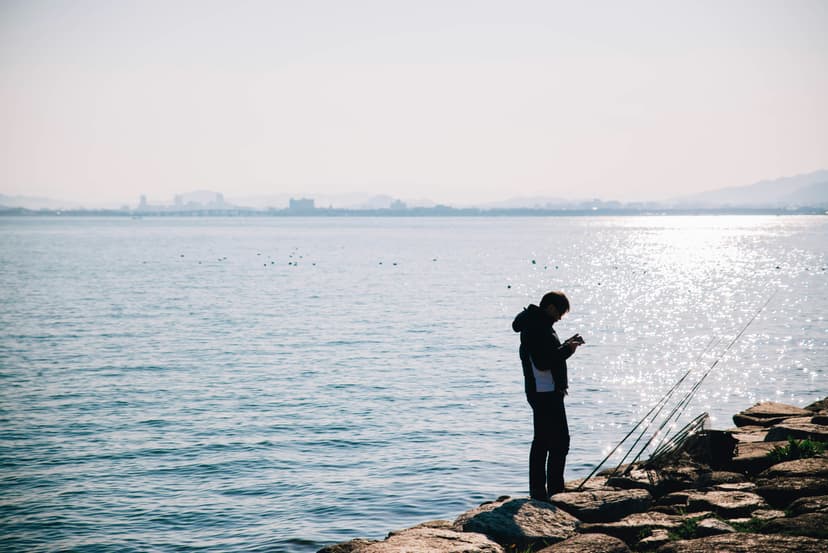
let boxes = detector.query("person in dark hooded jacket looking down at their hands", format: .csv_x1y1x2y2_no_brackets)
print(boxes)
512,292,584,501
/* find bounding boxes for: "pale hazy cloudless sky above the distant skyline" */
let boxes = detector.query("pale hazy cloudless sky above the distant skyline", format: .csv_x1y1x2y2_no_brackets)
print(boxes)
0,0,828,205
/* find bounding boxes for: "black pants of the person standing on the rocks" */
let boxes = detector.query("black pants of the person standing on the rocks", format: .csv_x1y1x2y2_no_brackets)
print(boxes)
527,392,569,499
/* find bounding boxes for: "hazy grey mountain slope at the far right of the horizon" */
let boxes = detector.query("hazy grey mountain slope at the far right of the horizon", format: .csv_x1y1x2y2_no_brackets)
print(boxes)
674,170,828,208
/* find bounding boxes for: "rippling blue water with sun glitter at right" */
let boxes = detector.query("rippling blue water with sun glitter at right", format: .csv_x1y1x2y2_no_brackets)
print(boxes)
0,216,828,552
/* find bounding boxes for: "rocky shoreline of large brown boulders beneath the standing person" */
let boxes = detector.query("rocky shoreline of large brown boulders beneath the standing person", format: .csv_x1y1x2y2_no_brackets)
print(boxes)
319,398,828,553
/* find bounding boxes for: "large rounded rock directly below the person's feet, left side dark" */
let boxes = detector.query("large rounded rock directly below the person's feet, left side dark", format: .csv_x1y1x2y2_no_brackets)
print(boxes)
454,498,580,549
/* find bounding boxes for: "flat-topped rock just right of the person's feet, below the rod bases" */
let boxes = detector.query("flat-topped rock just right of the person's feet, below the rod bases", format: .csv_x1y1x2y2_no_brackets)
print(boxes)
551,490,652,522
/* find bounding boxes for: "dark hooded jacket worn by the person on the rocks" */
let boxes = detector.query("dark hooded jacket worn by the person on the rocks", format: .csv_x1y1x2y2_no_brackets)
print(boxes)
512,304,572,395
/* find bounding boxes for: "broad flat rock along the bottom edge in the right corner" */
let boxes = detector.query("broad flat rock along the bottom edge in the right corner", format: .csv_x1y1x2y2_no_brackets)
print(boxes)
658,533,828,553
